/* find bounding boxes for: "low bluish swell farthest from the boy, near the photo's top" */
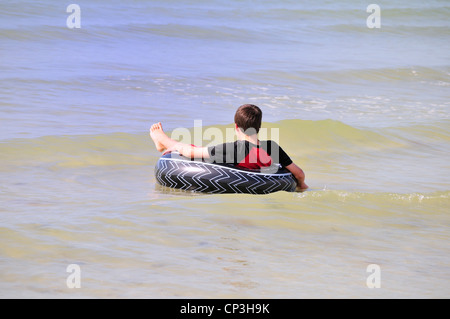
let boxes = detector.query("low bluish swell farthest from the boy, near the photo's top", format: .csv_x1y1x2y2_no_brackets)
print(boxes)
0,21,450,44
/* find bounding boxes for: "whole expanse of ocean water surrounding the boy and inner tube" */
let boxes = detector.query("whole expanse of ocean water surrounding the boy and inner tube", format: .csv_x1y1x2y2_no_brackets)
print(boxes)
0,0,450,298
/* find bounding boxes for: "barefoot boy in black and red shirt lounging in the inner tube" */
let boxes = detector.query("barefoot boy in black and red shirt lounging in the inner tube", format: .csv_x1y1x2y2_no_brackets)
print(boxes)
150,104,308,191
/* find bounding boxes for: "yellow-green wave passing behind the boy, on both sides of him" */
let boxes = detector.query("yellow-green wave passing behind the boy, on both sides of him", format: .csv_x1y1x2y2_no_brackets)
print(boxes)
0,119,450,169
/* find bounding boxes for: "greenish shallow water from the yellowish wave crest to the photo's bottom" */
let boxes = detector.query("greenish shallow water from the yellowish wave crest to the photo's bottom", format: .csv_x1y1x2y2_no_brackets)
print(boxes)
0,120,450,298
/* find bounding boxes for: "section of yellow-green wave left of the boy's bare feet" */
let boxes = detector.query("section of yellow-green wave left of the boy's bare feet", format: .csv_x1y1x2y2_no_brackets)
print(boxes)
0,133,153,169
